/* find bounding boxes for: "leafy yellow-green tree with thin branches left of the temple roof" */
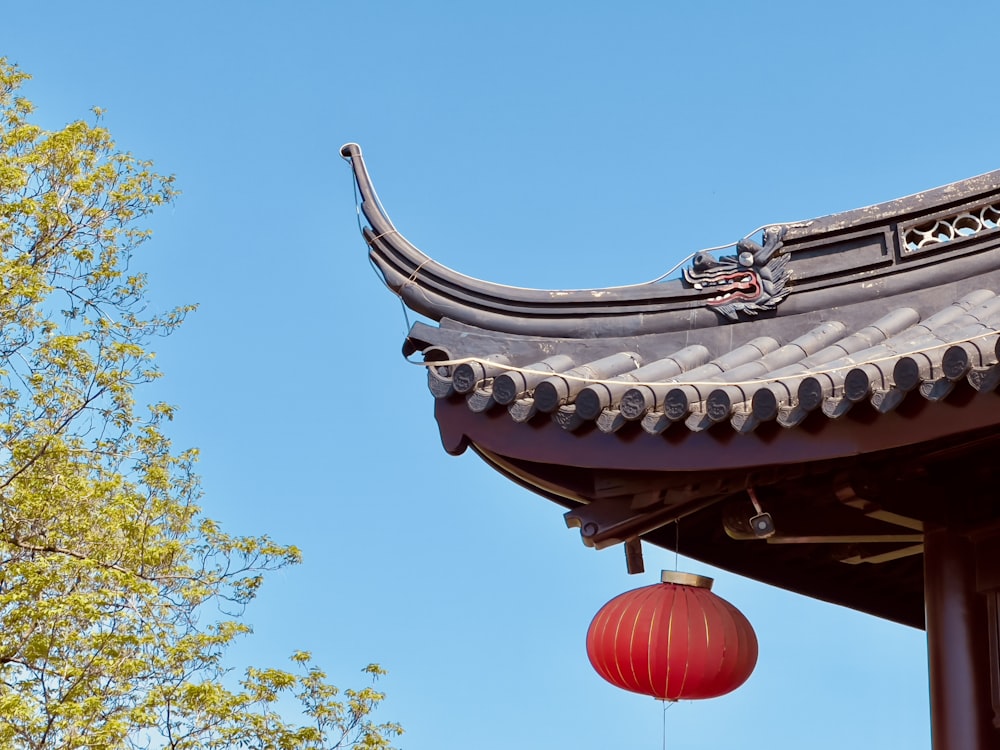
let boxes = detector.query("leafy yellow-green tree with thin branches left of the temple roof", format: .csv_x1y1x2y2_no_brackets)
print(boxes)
0,58,401,750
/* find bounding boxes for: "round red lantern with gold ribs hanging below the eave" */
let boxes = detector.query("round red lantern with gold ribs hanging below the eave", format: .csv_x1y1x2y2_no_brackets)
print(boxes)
587,571,757,701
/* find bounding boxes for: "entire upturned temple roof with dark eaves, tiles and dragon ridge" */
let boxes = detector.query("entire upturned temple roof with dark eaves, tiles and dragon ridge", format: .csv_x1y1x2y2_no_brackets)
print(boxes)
343,145,1000,627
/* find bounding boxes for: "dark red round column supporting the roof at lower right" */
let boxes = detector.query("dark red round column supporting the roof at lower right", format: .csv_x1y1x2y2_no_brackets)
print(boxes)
924,530,1000,750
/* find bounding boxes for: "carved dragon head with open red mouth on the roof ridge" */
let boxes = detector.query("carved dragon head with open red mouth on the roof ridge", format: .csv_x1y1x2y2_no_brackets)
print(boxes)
684,226,790,320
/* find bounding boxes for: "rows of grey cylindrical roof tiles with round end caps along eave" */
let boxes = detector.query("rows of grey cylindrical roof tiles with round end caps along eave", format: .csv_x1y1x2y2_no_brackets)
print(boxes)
420,289,1000,434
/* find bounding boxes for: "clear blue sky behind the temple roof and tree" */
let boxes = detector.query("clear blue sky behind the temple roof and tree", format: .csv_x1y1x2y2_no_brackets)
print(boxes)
0,0,1000,750
